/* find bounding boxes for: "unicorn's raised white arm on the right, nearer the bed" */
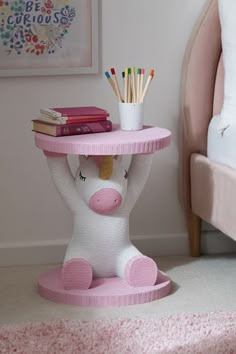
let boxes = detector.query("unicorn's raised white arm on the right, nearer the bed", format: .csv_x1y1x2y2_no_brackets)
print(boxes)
122,154,153,211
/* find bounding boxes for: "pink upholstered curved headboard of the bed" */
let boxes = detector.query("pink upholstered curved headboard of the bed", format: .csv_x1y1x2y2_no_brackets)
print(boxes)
179,0,223,210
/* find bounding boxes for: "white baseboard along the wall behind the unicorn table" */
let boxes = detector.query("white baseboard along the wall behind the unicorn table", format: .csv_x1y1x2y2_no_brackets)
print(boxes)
0,231,236,266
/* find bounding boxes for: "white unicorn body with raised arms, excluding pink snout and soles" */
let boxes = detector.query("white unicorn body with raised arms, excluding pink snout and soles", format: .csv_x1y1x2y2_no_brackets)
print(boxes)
47,155,152,278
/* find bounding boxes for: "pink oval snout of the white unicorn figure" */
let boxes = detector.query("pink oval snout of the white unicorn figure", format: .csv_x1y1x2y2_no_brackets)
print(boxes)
89,188,122,215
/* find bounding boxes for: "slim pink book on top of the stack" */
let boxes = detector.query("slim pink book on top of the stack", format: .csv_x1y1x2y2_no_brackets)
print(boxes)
50,106,109,117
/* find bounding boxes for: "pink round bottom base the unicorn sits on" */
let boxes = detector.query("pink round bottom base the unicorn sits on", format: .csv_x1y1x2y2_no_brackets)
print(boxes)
38,267,171,307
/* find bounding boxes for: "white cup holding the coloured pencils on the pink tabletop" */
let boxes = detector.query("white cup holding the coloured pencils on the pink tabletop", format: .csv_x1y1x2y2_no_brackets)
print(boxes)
119,103,144,130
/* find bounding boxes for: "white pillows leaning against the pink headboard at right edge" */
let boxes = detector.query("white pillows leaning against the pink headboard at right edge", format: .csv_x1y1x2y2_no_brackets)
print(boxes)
207,0,236,168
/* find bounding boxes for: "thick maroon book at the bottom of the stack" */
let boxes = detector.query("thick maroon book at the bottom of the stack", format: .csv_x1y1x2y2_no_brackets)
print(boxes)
32,119,112,136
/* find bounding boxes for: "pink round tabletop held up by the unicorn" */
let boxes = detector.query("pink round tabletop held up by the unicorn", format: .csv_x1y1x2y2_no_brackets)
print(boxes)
35,124,171,155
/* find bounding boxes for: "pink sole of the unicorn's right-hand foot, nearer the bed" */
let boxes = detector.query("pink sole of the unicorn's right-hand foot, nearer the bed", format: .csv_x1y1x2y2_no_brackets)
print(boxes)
125,256,158,287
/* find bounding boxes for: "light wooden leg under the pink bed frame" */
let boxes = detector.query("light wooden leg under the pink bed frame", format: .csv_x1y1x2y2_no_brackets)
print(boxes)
186,211,201,257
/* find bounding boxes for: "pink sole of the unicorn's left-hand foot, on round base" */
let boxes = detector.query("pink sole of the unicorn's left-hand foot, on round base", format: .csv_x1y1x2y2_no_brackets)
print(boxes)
62,258,93,290
